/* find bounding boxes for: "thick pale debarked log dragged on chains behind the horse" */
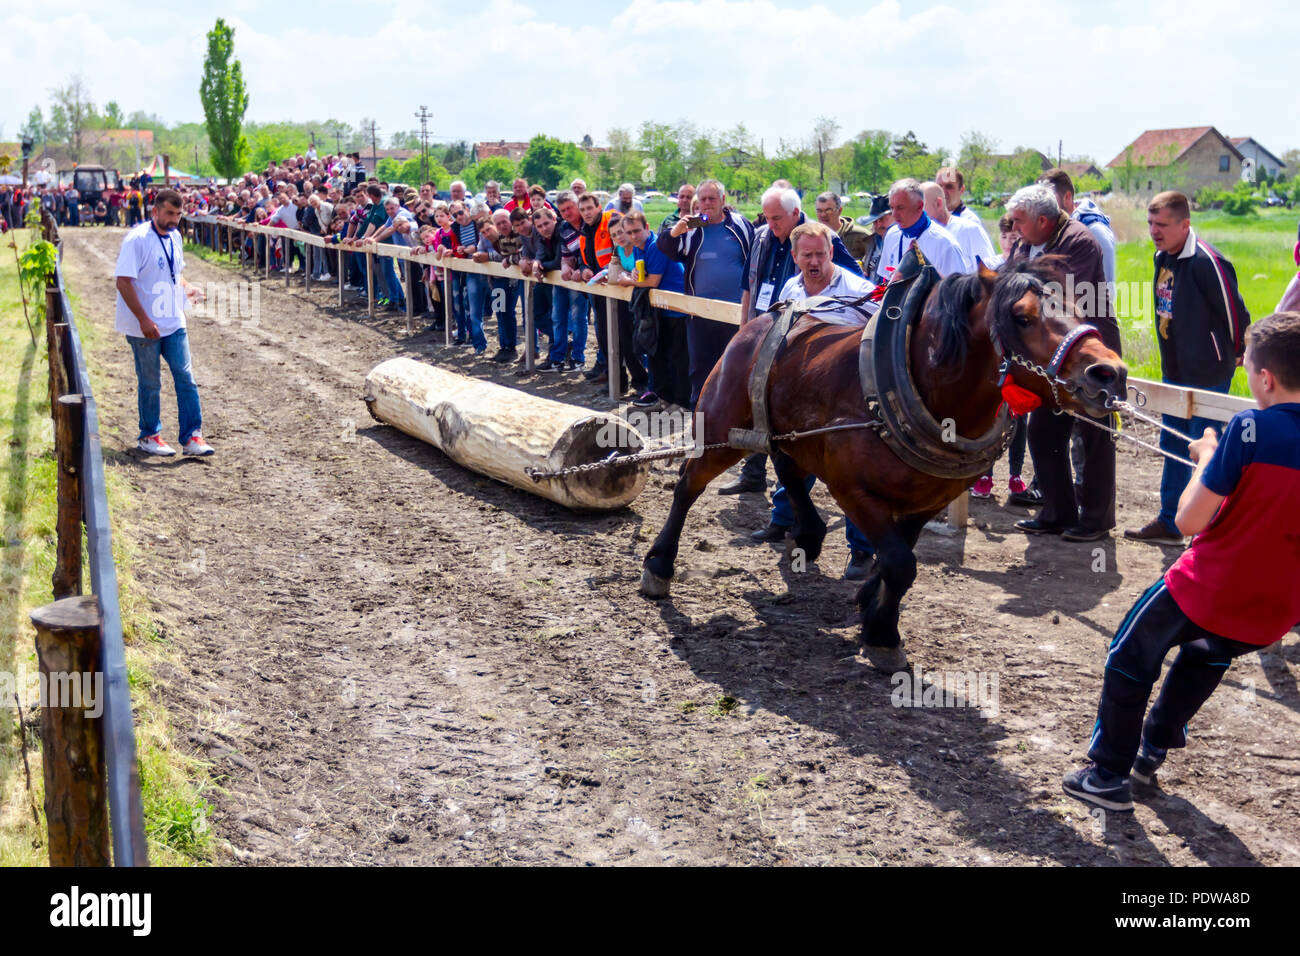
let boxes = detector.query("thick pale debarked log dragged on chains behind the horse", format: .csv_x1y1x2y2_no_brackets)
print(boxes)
365,359,649,511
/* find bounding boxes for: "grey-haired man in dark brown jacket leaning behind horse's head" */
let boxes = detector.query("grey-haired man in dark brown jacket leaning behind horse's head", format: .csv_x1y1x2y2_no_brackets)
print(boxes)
1006,185,1123,541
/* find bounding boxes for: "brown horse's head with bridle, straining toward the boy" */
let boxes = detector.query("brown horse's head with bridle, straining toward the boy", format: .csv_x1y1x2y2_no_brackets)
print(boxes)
979,256,1128,416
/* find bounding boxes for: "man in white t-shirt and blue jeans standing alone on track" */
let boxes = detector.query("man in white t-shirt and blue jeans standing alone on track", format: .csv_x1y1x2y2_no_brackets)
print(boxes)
114,189,212,457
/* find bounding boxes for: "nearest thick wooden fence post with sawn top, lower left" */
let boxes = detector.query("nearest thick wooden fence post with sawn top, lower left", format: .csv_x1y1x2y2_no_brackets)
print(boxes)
31,596,111,866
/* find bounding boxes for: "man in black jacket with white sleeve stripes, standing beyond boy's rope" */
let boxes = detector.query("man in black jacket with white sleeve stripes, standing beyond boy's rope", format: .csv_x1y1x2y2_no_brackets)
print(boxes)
1125,191,1251,546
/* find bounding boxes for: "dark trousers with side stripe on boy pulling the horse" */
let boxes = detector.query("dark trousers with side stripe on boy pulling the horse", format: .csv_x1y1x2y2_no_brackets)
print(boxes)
1088,579,1264,777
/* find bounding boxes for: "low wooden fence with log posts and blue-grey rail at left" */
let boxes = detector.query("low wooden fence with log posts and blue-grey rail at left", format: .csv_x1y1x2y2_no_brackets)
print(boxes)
31,222,148,866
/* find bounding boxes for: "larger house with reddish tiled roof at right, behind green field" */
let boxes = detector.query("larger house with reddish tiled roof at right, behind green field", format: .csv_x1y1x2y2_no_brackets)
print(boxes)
1106,126,1242,194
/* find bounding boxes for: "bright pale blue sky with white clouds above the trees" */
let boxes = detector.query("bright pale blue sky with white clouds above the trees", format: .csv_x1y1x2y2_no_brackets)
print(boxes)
0,0,1300,163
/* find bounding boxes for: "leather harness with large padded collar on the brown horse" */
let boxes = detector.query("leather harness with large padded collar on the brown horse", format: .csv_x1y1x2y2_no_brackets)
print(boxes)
727,245,1100,480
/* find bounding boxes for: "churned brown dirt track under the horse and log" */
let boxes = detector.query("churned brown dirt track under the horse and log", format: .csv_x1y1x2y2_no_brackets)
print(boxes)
66,229,1300,865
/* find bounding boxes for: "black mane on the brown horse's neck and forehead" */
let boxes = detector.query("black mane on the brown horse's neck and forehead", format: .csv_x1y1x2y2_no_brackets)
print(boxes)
933,256,1061,376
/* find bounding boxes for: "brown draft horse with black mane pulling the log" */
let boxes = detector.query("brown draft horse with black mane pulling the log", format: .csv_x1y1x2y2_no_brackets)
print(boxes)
641,258,1127,670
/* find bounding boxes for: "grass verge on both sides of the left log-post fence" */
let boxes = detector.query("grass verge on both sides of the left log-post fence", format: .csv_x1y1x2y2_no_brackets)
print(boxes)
0,232,211,866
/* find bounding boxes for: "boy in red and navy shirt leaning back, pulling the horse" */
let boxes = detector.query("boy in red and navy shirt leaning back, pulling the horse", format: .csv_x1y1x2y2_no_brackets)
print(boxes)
1062,312,1300,810
